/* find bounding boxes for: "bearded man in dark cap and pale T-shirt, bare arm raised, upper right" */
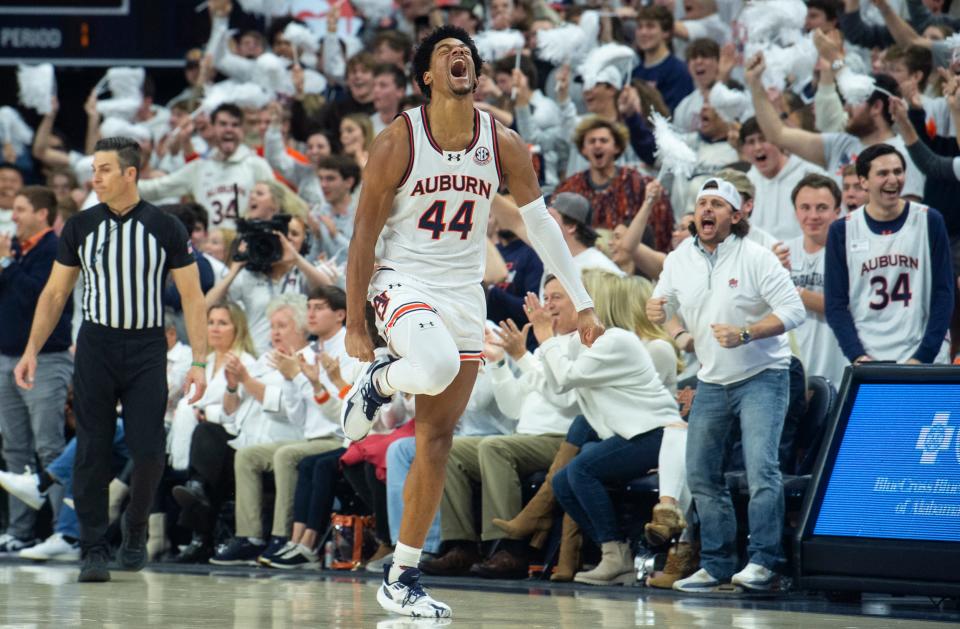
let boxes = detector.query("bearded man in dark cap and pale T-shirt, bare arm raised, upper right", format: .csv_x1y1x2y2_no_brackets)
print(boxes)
746,53,925,200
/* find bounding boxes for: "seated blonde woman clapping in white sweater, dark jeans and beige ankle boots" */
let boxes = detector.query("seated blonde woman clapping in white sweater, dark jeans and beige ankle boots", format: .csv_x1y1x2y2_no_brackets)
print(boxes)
528,271,683,585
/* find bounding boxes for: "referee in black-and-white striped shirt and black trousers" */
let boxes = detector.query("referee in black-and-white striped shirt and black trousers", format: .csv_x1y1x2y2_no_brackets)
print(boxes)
14,137,206,582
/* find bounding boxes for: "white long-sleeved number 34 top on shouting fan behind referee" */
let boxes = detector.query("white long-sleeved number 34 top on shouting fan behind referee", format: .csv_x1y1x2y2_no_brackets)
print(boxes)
139,144,274,229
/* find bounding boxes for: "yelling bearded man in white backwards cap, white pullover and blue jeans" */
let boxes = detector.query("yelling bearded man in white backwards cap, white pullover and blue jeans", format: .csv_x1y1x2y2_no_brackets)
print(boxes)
647,179,805,592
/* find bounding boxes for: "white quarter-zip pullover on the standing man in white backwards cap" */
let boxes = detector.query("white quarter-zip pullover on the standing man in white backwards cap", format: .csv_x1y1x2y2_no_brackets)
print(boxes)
653,235,806,384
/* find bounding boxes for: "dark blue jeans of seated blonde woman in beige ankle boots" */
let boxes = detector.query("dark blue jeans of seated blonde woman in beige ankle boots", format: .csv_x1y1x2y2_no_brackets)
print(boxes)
553,416,663,544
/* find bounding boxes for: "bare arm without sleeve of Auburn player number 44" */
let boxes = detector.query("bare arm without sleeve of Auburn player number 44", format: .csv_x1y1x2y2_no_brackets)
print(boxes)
346,118,410,362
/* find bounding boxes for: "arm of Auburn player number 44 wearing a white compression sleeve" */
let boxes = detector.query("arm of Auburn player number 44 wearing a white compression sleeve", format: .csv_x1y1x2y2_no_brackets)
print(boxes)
498,125,603,346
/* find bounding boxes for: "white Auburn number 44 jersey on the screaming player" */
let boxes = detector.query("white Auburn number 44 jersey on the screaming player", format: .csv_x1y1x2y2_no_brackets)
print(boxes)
374,106,501,288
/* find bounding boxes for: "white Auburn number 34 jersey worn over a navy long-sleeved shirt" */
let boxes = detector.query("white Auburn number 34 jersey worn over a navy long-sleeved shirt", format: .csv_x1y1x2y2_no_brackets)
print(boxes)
845,201,950,363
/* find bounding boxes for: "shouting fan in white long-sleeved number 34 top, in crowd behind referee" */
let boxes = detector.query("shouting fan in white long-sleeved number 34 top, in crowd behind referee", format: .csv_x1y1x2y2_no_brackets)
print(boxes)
139,104,273,229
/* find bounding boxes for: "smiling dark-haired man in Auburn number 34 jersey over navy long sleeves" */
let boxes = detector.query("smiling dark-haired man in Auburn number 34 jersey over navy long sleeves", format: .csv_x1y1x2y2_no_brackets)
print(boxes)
824,144,953,364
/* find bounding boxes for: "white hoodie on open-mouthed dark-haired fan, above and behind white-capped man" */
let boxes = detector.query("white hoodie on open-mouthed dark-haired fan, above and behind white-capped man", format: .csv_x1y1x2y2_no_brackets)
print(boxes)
747,155,826,242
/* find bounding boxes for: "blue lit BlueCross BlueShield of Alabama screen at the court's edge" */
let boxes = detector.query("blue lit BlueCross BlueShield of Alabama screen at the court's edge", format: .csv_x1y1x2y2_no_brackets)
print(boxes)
813,382,960,542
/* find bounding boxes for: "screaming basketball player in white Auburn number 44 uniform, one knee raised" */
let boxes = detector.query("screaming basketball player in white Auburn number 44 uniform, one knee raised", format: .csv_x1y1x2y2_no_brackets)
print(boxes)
341,26,603,618
